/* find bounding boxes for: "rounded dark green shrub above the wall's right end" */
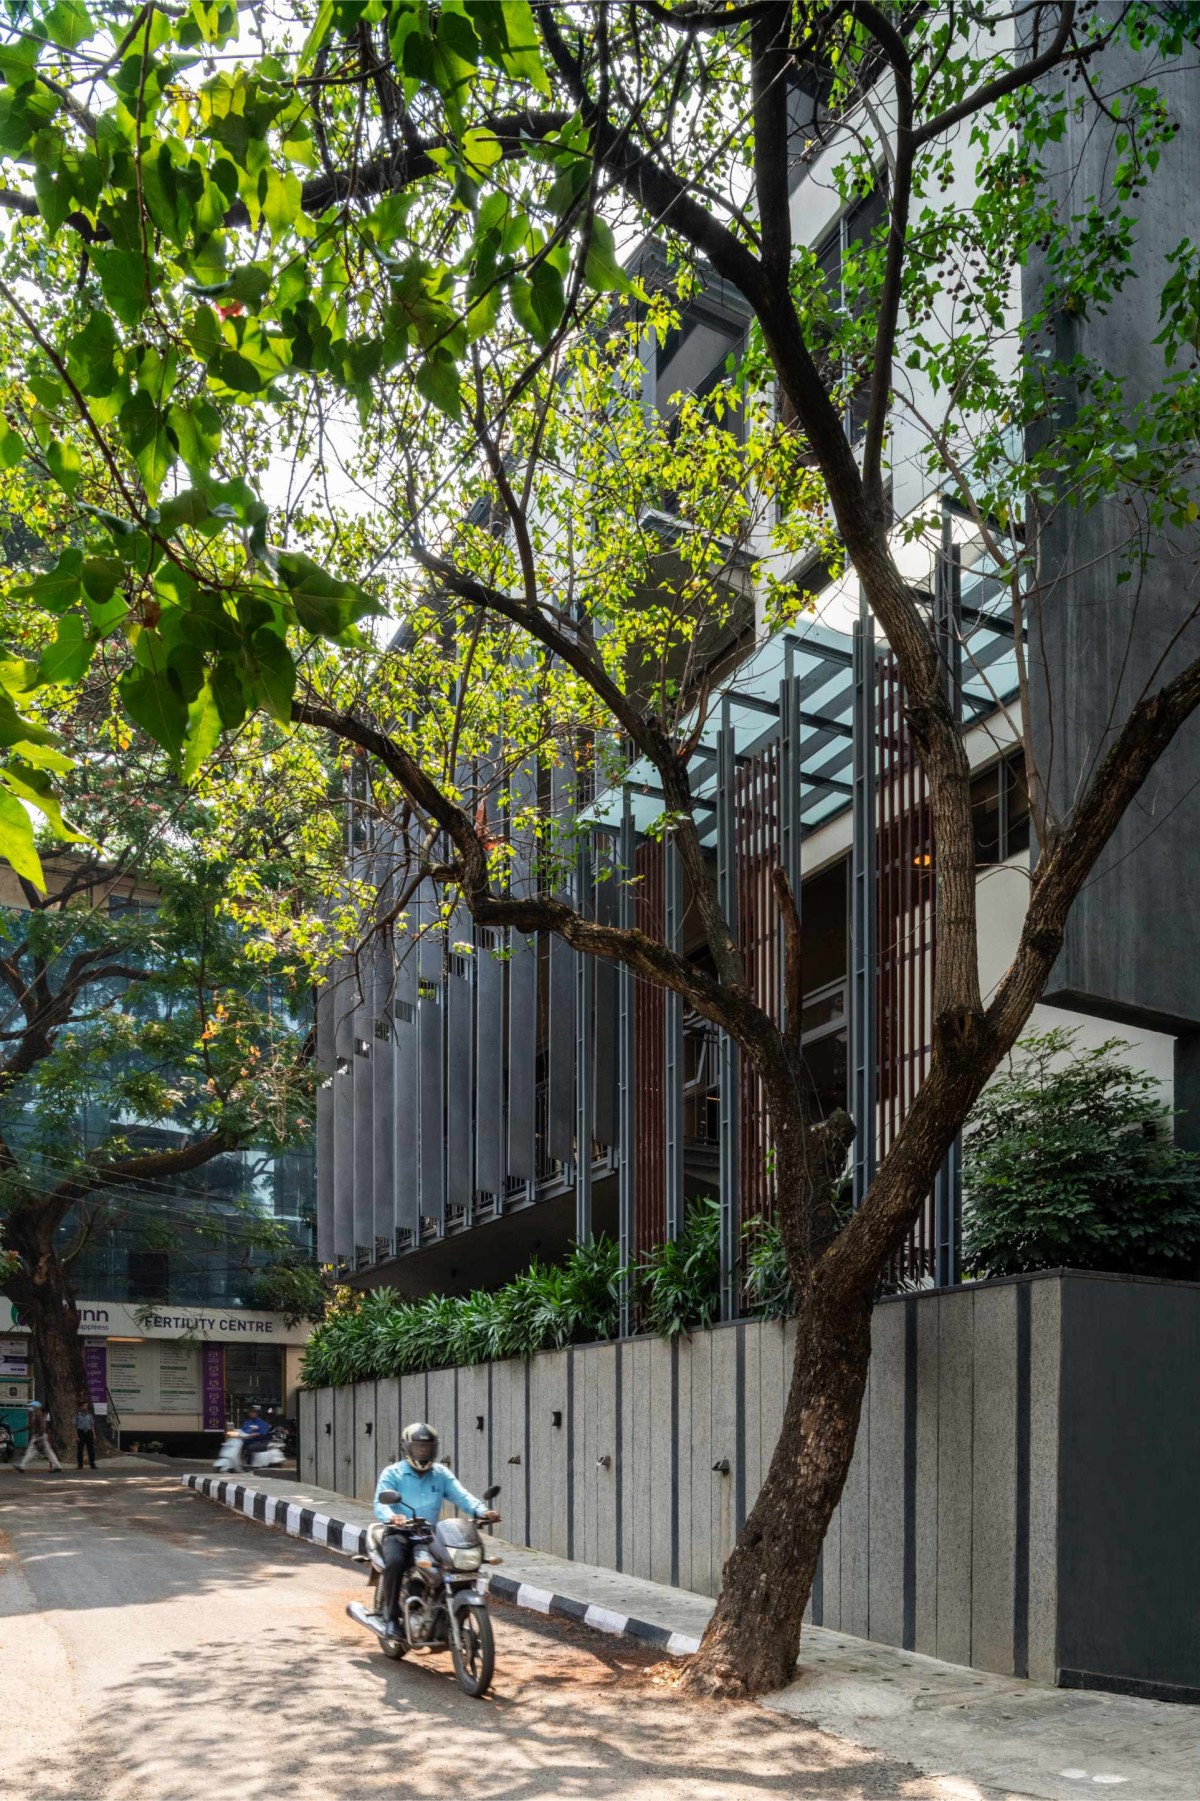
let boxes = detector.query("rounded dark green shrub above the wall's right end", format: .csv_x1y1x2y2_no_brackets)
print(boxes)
962,1030,1200,1277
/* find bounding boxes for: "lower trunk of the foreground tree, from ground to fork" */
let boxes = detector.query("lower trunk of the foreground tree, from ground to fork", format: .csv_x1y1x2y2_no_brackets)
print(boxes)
685,1293,872,1698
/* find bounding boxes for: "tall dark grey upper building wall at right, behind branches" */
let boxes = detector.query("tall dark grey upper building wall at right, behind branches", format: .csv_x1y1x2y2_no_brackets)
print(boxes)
1023,49,1200,1037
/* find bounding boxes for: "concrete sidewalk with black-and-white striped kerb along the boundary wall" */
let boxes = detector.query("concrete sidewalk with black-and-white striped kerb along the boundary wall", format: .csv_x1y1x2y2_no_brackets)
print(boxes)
180,1473,1200,1801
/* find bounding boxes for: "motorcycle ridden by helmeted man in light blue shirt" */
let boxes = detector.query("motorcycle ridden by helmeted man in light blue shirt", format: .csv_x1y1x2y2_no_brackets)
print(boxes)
346,1488,499,1697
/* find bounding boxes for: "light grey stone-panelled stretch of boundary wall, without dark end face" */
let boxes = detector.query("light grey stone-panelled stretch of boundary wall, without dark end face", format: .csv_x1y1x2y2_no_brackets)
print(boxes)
301,1277,1061,1680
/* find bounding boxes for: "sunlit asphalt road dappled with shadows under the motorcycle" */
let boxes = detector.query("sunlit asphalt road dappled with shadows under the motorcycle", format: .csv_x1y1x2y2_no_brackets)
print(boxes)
0,1466,980,1801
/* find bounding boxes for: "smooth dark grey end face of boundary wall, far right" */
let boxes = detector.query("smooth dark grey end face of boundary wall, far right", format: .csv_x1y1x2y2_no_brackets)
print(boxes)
1058,1277,1200,1700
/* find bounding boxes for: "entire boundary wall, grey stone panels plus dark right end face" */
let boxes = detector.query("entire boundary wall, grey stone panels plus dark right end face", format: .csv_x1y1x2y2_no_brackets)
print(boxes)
293,1273,1200,1698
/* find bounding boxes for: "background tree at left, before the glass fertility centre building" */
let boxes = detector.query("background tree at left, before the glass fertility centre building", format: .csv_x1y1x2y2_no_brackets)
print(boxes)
0,461,312,1430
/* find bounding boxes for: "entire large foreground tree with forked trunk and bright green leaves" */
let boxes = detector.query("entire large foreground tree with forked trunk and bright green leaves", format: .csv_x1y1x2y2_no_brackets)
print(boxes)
0,0,1200,1693
